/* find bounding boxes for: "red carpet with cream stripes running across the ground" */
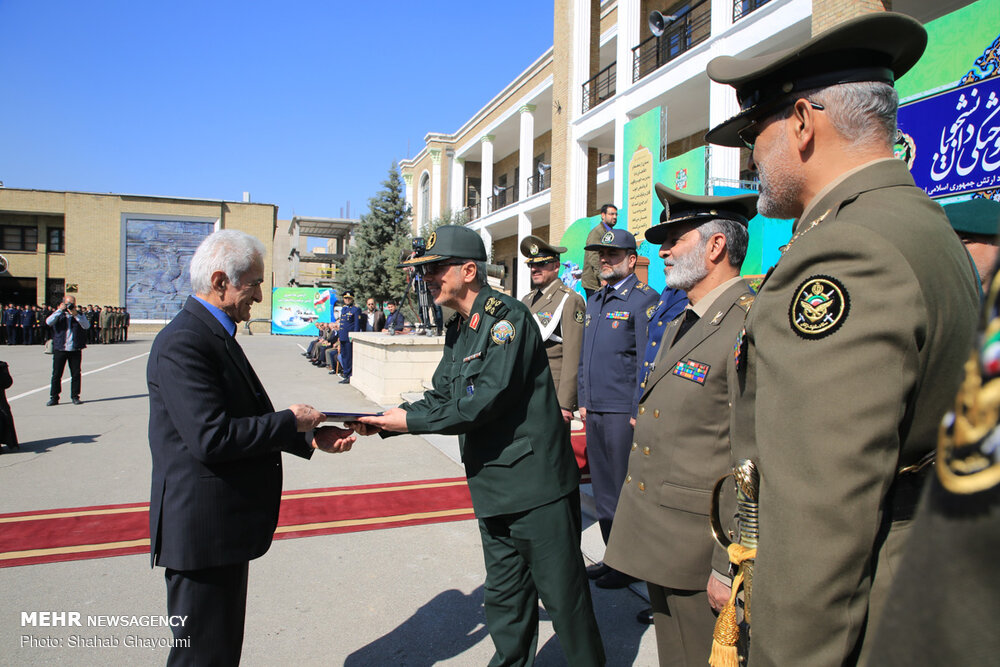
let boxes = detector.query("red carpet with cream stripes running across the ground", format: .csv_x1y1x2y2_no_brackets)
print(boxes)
0,477,474,567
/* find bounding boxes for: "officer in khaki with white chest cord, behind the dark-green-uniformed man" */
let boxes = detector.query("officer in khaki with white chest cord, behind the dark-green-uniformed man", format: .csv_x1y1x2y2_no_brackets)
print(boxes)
521,236,587,423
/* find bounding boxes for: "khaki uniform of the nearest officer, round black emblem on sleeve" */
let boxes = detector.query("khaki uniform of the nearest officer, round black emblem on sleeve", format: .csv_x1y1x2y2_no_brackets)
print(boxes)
731,159,979,667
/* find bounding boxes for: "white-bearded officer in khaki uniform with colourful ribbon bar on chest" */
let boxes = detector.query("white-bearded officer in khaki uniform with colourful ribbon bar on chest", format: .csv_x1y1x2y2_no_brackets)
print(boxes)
604,183,757,667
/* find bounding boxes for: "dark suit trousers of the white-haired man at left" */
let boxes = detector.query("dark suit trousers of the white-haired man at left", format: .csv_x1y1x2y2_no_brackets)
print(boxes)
164,562,248,667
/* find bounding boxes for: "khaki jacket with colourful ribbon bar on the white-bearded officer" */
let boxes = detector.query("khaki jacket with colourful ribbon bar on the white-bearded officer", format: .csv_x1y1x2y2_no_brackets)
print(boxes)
604,280,753,590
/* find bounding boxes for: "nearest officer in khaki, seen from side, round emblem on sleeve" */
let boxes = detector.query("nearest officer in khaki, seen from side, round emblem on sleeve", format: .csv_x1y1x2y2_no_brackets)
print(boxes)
706,12,979,667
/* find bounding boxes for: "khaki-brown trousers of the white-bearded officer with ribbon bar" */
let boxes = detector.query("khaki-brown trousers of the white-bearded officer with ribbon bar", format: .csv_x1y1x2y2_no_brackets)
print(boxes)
646,577,715,667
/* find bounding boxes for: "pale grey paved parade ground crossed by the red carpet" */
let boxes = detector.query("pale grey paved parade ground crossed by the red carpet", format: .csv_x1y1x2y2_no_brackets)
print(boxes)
0,331,657,667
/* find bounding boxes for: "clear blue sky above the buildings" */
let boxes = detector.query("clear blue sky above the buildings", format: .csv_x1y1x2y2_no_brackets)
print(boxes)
0,0,552,219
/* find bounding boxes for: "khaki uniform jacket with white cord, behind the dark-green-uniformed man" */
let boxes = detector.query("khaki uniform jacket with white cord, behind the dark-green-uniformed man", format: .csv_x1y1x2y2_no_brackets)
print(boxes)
521,278,587,412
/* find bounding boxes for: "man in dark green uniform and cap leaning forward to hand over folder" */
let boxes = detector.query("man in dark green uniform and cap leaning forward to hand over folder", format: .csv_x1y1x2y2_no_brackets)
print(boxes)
358,225,604,667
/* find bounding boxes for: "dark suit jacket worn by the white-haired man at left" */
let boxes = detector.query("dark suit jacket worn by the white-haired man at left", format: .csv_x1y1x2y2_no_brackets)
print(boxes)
146,297,312,570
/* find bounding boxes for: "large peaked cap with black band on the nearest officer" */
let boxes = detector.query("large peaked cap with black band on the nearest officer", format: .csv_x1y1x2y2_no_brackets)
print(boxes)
705,12,927,148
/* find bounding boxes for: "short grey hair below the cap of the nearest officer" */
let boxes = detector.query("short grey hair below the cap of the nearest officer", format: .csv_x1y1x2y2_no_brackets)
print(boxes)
797,81,899,148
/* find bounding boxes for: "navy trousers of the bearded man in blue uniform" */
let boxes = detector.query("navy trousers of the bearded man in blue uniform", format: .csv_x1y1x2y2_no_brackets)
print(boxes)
587,410,632,544
